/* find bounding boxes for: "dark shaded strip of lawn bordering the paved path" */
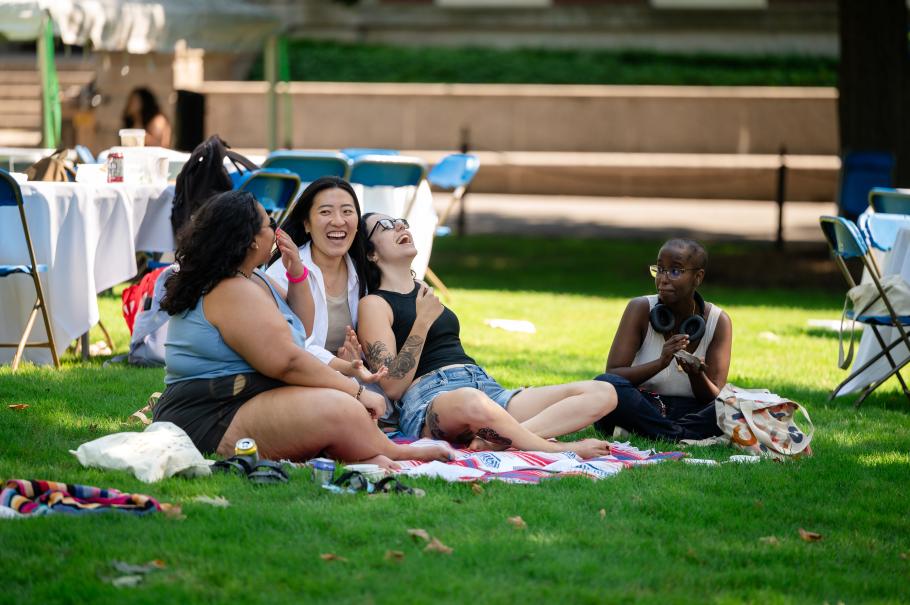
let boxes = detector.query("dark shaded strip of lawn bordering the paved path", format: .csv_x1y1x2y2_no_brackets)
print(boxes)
432,235,844,308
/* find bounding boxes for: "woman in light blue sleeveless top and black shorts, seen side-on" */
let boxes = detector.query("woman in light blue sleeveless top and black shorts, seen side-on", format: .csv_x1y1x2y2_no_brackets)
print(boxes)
155,191,450,467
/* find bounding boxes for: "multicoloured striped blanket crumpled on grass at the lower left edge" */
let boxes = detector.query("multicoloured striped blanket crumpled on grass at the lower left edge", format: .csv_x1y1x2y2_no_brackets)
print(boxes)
0,479,161,516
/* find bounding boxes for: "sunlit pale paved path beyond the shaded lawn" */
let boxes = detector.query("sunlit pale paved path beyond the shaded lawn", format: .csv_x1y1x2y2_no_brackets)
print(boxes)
434,193,837,242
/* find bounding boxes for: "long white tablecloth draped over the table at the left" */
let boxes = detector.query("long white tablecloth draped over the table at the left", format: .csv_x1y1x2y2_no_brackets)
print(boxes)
0,182,173,363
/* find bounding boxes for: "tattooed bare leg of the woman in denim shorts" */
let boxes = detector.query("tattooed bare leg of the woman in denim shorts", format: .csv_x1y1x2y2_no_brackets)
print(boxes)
423,388,610,458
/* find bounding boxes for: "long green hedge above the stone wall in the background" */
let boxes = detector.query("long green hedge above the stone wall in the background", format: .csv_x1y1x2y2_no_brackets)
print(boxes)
250,40,837,86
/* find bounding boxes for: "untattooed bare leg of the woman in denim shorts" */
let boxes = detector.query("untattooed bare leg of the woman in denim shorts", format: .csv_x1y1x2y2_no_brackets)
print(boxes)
507,380,616,437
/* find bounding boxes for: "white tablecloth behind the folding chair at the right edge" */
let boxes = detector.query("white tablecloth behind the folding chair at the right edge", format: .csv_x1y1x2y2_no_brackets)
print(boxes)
838,228,910,395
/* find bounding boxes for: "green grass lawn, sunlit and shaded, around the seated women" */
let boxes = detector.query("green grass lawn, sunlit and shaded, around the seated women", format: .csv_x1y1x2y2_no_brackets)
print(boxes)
0,237,910,605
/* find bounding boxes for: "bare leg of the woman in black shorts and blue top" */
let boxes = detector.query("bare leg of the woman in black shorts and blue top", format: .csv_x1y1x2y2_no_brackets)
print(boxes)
218,387,451,461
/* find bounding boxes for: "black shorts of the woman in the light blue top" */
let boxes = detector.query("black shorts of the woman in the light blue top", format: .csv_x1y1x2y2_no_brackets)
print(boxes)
154,373,287,454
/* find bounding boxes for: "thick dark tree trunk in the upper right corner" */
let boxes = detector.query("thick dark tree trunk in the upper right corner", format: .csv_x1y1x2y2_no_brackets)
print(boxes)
838,0,910,187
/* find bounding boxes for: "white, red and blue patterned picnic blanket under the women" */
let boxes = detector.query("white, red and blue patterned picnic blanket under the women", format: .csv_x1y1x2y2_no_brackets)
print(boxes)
395,439,686,484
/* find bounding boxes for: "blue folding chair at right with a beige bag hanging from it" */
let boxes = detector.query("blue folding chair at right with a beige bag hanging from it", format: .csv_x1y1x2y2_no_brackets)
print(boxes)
819,216,910,407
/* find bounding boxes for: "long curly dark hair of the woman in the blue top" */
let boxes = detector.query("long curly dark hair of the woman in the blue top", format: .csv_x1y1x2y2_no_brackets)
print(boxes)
161,191,262,315
